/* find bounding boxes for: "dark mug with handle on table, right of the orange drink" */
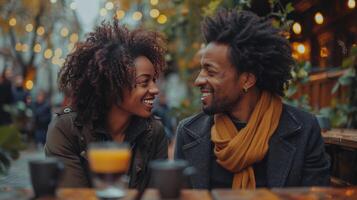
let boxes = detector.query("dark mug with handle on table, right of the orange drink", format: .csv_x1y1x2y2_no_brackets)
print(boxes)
150,160,195,199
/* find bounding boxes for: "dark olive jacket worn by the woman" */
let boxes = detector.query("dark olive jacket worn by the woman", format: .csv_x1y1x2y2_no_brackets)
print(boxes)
45,108,168,189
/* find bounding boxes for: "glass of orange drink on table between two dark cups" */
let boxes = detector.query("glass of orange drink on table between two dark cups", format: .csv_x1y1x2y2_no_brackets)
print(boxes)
88,142,131,199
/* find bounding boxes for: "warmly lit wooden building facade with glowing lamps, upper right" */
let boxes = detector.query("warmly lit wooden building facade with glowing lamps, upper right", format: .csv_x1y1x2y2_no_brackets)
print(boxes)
290,0,357,110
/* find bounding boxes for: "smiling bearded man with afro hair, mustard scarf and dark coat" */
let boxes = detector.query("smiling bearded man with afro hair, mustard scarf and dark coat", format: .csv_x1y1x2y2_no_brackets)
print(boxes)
175,10,330,189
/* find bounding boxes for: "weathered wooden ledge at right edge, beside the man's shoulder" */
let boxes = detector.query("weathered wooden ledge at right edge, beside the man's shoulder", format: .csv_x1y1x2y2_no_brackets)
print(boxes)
322,129,357,149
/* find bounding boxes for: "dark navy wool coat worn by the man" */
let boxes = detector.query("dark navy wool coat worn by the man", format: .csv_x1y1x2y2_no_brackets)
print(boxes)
175,105,330,189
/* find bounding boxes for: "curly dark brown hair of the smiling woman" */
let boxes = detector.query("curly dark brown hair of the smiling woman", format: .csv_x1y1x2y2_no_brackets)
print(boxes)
58,20,166,123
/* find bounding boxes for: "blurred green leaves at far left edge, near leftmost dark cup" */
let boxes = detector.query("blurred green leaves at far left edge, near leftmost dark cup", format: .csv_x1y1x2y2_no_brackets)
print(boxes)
0,126,25,174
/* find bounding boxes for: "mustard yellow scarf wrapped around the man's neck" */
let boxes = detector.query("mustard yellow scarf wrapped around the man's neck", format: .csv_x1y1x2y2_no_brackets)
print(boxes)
211,92,282,189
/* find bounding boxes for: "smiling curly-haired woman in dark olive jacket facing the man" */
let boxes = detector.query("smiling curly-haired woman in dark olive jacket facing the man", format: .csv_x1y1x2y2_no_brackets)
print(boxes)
45,21,168,189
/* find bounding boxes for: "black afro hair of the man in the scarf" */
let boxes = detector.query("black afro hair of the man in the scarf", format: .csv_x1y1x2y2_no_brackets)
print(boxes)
202,9,294,96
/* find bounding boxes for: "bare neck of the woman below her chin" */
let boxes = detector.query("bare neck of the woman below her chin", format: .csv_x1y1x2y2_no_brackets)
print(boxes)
107,105,131,139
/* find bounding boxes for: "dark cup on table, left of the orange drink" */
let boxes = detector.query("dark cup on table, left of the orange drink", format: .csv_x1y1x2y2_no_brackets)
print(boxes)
29,158,63,198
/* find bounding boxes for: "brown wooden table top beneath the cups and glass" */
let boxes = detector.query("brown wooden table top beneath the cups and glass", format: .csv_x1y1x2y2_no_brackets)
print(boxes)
0,187,357,200
